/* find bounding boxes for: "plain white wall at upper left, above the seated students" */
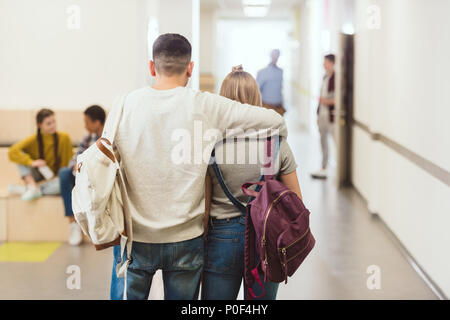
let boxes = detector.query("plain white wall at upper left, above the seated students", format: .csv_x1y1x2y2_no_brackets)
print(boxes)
0,0,153,109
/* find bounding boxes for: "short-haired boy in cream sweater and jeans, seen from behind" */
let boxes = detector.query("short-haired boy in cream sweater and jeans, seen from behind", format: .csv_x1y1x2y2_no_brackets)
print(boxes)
112,34,286,300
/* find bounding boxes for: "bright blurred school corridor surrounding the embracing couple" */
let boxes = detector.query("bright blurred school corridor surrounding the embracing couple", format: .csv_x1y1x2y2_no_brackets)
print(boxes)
0,0,450,300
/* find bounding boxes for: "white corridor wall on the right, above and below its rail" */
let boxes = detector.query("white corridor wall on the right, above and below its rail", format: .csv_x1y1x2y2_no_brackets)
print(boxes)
352,0,450,296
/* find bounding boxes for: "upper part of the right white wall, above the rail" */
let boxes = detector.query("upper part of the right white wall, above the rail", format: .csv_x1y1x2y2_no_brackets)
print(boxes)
355,0,450,171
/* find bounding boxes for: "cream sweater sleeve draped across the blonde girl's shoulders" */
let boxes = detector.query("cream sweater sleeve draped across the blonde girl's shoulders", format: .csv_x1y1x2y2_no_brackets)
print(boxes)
202,93,287,138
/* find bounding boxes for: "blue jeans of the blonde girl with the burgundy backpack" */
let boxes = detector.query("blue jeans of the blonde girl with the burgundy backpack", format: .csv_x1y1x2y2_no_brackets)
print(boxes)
202,216,278,300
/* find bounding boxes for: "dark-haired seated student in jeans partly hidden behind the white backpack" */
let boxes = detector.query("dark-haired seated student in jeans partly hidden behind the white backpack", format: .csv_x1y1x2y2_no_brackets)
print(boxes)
59,105,106,246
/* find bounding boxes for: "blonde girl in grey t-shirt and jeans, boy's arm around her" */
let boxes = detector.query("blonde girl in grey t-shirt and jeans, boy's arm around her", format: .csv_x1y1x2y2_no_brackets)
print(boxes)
201,66,302,300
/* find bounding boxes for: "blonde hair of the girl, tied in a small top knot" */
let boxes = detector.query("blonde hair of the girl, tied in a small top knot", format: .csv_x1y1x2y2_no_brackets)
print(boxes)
220,65,262,107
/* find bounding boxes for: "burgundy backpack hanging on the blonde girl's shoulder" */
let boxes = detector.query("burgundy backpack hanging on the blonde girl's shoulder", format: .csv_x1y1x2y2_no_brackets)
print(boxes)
212,138,315,299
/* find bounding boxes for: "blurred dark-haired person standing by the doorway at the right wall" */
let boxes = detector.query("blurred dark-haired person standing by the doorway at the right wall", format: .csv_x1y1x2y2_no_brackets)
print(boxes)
311,54,335,179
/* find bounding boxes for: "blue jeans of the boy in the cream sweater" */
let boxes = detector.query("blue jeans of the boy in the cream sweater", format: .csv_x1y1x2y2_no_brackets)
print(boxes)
110,236,204,300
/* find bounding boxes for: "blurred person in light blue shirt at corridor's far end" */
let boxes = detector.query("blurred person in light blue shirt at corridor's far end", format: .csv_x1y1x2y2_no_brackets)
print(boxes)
256,49,286,115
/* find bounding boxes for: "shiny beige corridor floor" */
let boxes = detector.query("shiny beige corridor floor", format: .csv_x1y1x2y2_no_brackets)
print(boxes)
0,114,437,299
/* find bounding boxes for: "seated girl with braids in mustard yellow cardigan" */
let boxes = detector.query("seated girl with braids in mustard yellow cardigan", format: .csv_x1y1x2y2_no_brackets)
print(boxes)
8,109,73,201
